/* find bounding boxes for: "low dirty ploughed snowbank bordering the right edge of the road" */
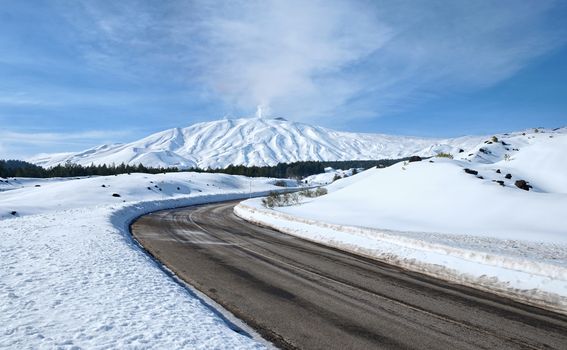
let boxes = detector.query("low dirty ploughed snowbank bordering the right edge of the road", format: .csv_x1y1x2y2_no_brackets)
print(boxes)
235,199,567,314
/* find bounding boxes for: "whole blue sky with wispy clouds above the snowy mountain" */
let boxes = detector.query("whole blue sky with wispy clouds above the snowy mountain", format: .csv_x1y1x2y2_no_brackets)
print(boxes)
0,0,567,158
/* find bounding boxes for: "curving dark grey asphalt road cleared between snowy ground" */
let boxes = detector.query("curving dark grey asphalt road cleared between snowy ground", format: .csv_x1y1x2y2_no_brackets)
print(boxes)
132,202,567,349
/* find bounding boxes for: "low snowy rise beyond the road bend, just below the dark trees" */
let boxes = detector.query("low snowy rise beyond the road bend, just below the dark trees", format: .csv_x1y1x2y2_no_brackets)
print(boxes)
0,172,293,219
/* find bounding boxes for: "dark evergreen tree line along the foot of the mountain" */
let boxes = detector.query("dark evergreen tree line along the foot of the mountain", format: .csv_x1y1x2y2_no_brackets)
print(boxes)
0,158,408,179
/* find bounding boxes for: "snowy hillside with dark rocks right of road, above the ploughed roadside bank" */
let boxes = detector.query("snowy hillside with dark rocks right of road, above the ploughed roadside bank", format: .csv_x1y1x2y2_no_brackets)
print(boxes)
272,129,567,243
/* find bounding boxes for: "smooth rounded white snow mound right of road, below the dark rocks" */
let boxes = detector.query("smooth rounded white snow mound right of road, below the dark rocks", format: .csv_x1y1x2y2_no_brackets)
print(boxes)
278,159,567,243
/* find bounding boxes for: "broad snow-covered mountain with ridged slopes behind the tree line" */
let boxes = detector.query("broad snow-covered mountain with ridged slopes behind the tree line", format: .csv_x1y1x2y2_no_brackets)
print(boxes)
30,118,486,168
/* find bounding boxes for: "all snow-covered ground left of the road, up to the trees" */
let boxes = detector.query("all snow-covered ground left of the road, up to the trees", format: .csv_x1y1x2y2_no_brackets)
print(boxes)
0,173,286,349
